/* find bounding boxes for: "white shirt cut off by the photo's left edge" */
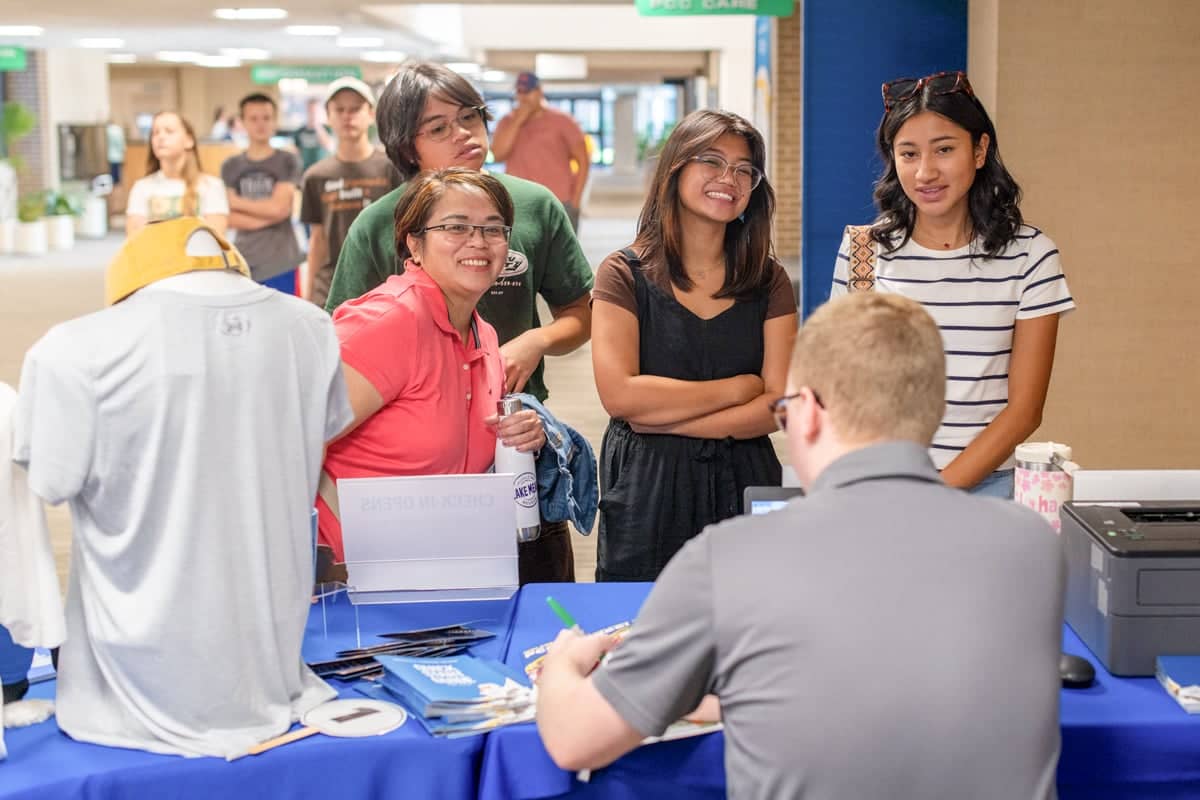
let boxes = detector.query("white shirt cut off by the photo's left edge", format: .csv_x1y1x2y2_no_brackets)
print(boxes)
0,383,65,759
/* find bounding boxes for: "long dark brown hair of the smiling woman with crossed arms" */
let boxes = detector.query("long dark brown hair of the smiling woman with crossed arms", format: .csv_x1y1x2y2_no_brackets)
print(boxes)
634,110,775,300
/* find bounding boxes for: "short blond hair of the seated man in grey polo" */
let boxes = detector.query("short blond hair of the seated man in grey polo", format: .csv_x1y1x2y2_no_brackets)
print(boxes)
788,291,946,445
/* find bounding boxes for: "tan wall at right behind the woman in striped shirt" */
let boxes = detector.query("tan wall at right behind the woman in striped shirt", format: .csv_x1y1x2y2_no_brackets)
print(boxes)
970,0,1200,468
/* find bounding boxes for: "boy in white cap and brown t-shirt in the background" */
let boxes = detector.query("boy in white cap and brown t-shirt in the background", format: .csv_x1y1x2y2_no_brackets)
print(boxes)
300,77,402,308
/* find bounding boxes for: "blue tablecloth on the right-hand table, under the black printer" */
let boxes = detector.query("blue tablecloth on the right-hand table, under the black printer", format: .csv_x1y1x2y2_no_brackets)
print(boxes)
480,583,1200,800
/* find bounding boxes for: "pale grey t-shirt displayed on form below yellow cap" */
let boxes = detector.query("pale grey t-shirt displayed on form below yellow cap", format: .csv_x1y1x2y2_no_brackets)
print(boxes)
14,275,353,757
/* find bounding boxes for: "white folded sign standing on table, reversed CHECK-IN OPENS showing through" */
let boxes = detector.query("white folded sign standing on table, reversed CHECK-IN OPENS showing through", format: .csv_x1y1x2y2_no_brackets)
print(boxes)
337,473,517,603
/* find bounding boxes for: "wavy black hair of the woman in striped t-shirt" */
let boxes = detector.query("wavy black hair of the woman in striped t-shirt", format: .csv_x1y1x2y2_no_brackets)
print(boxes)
871,76,1022,258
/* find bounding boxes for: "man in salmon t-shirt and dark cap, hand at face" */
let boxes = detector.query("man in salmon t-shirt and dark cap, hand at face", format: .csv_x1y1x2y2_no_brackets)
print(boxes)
482,72,590,230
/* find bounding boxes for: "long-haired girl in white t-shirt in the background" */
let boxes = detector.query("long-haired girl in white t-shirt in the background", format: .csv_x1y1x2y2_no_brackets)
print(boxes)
125,112,229,236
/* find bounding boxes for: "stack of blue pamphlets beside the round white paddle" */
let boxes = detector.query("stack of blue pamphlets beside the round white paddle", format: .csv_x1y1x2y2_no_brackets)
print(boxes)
377,655,536,739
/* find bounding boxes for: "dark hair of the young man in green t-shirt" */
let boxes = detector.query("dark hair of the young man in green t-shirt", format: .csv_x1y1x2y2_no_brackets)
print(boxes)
376,61,492,181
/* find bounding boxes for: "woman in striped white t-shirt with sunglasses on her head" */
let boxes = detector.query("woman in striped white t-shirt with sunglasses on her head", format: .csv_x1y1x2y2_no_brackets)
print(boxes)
832,72,1075,497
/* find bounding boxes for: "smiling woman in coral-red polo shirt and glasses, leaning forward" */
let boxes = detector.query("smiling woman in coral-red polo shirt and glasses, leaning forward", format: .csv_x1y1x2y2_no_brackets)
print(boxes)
317,168,545,563
